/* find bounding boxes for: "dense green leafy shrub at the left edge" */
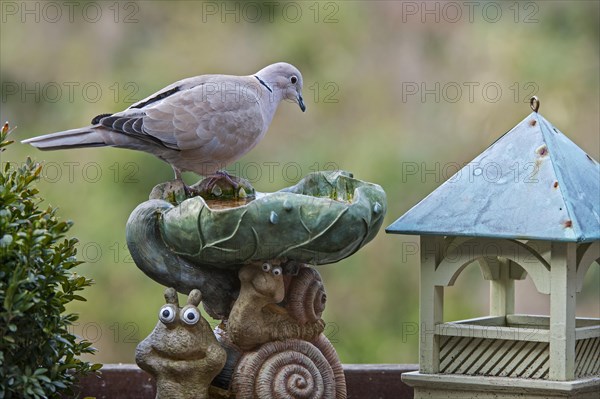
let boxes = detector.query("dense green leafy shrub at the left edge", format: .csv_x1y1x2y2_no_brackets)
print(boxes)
0,125,101,399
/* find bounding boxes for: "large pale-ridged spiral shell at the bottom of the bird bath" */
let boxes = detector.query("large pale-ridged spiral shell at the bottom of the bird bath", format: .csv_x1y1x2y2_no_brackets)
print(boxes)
232,339,338,399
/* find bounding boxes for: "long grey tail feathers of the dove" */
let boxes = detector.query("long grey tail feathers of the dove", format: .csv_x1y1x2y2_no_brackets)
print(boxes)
21,126,108,151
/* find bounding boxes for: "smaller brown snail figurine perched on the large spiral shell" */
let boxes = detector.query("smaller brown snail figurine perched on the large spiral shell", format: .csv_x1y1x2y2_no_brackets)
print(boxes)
227,262,325,350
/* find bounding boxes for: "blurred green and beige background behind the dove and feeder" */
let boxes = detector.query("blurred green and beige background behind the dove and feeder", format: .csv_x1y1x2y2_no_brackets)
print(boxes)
0,1,600,363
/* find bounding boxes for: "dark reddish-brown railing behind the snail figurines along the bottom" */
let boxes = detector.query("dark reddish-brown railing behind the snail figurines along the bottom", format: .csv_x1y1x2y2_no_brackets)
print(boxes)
78,364,418,399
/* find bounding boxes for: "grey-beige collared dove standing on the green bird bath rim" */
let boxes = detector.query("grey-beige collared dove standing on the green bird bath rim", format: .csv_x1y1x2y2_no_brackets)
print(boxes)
23,62,306,179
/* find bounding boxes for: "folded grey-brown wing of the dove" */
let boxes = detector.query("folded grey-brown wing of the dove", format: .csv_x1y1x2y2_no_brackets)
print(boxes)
99,78,264,153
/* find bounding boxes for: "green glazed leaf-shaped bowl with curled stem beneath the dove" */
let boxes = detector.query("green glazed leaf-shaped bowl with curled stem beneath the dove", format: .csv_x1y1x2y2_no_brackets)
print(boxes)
127,171,387,315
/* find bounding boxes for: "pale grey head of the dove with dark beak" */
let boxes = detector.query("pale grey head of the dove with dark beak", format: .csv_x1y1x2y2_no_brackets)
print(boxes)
256,62,306,112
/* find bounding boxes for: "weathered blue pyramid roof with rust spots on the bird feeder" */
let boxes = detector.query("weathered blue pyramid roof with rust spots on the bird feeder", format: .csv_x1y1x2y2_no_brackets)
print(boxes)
386,112,600,242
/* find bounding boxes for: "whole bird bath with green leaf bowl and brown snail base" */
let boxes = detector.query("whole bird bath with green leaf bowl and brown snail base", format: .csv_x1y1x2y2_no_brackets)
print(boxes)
127,172,386,399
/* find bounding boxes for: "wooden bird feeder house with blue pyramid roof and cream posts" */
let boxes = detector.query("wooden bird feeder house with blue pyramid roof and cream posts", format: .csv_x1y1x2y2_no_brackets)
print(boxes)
386,97,600,398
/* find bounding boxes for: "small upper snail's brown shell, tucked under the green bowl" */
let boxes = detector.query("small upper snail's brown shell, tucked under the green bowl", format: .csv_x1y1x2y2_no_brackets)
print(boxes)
286,267,327,324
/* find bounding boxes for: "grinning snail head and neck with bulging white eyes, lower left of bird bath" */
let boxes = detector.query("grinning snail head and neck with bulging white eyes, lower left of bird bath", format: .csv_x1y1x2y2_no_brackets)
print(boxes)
135,288,227,399
